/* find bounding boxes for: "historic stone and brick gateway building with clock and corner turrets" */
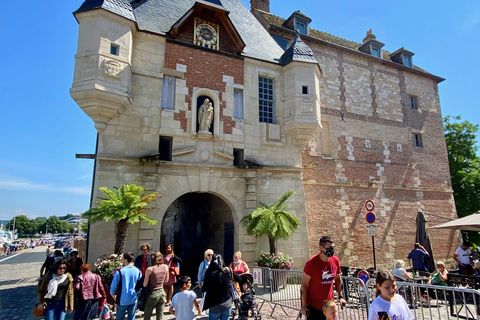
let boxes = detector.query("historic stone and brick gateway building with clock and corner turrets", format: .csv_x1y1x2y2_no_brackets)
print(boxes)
70,0,458,275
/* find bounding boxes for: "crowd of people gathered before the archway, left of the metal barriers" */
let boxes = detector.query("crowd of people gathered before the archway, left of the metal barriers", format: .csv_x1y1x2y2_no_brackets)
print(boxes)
36,243,256,320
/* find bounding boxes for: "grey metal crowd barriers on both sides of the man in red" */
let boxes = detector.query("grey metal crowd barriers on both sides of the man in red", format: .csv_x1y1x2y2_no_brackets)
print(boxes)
250,267,480,320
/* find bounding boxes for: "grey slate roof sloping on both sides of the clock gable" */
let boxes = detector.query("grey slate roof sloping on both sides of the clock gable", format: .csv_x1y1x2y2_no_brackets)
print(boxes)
75,0,283,63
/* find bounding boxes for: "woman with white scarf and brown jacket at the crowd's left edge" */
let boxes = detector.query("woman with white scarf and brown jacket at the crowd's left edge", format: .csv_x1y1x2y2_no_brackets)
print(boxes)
37,260,73,320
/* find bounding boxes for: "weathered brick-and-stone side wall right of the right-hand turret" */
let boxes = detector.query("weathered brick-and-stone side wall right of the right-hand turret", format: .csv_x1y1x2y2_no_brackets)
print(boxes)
254,10,458,268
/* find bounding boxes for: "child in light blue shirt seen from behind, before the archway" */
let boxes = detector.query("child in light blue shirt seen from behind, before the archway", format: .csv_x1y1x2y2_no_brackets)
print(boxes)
168,276,202,320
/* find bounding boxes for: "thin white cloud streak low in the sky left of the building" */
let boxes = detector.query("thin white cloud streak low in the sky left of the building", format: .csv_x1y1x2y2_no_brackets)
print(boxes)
0,173,90,195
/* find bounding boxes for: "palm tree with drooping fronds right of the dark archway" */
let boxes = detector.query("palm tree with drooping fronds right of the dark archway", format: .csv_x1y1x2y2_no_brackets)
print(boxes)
241,191,300,254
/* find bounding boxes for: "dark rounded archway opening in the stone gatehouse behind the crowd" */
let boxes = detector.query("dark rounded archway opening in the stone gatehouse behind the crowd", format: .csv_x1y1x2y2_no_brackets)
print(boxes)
160,192,235,283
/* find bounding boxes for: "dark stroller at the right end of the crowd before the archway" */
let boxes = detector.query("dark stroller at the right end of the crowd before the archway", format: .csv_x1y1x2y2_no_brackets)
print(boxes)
230,272,262,320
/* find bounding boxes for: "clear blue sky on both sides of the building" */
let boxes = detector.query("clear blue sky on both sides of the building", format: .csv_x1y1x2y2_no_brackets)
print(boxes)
0,0,480,220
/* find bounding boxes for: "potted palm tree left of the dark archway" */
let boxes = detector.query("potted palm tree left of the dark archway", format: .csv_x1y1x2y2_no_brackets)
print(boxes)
83,184,162,254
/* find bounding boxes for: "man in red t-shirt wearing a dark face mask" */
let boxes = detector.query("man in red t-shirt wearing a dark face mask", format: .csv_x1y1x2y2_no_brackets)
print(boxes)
300,236,347,320
